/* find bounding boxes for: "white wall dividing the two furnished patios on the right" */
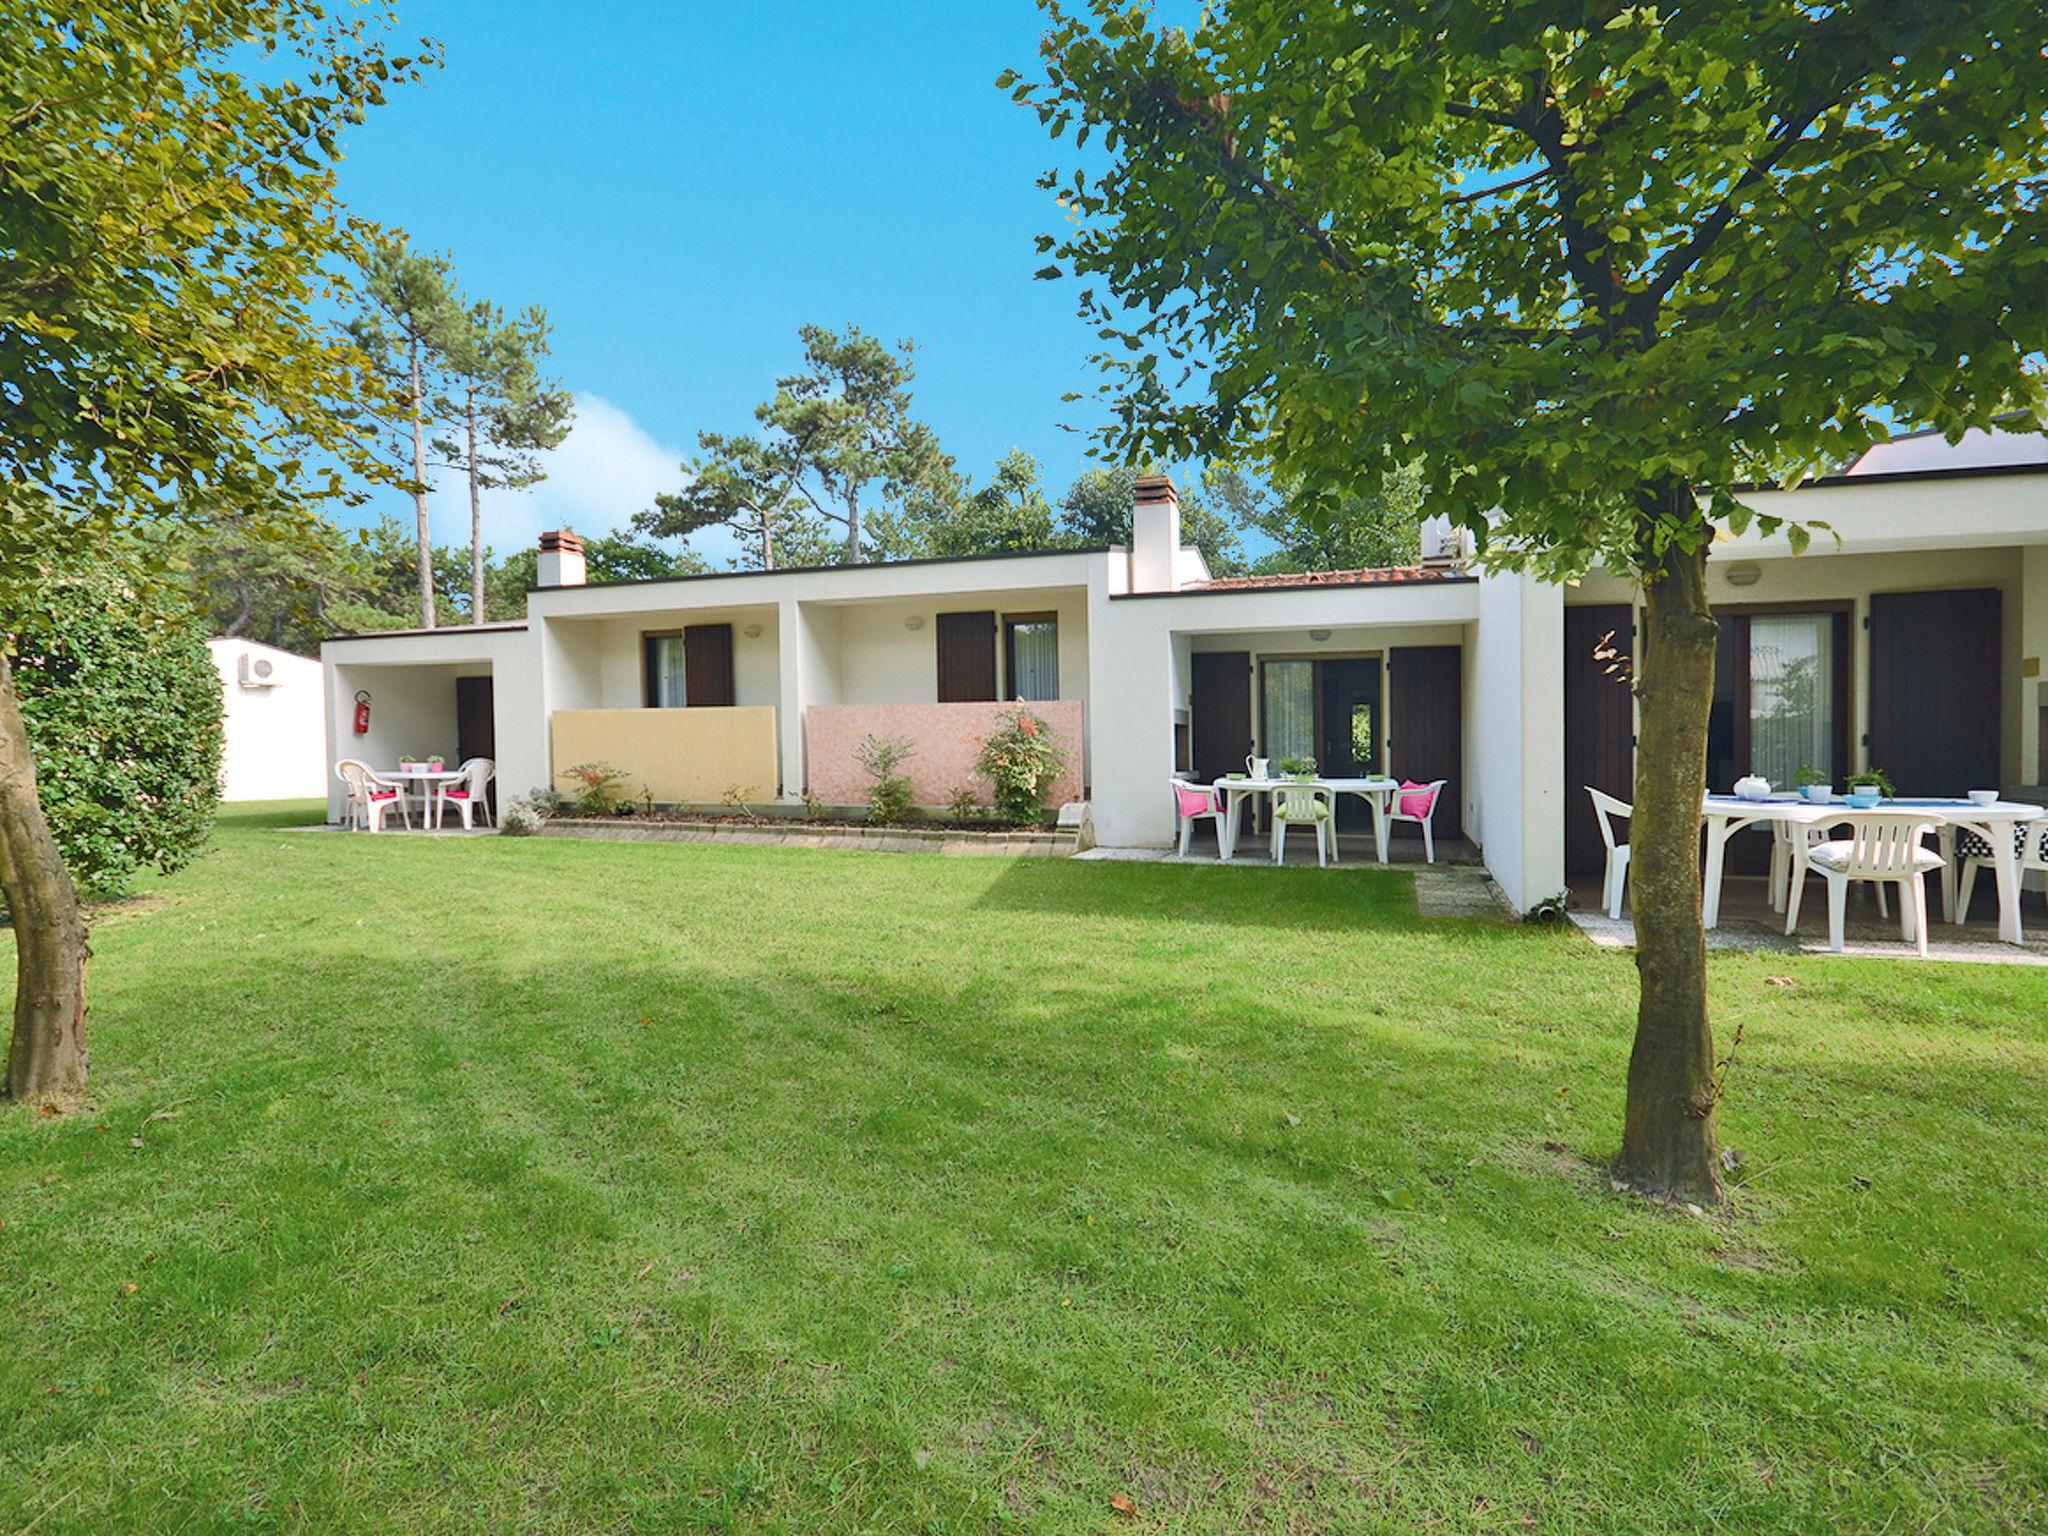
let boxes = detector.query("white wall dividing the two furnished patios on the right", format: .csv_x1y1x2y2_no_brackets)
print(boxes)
1464,573,1565,911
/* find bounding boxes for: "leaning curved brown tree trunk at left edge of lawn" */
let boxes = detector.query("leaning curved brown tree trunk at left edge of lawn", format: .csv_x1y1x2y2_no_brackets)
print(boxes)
0,651,92,1104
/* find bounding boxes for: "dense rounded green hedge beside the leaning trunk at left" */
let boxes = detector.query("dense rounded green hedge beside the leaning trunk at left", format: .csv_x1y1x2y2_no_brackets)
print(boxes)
12,575,221,897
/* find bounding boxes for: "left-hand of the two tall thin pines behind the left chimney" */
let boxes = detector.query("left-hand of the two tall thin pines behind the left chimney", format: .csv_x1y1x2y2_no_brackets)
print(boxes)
348,233,467,629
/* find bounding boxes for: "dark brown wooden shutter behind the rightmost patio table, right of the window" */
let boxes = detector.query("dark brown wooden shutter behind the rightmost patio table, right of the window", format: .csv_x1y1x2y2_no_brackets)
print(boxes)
1870,588,2003,795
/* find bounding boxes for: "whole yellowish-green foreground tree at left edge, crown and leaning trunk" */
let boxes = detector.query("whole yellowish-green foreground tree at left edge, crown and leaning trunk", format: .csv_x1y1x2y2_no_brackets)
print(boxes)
0,0,432,1102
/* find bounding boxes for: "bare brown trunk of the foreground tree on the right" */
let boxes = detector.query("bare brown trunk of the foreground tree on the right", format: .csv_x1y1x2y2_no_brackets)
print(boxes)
1618,485,1722,1204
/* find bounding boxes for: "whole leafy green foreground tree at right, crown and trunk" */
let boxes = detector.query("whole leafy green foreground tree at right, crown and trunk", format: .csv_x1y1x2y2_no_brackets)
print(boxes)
1019,0,2048,1200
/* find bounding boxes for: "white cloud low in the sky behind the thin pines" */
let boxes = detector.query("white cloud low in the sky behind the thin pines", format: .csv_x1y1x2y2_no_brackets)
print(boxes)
428,395,692,555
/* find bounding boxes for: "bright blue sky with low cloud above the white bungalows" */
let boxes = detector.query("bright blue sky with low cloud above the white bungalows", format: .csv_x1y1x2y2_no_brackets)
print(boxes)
327,0,1146,557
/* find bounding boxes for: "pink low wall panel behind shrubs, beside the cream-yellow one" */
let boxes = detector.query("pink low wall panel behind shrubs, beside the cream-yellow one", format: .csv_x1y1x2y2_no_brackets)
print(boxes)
803,698,1083,805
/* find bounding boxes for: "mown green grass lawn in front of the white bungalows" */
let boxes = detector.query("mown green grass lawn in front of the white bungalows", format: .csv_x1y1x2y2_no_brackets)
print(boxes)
0,811,2048,1532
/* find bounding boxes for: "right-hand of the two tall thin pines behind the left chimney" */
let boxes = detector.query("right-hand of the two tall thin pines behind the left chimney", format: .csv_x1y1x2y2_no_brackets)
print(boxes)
434,301,575,625
